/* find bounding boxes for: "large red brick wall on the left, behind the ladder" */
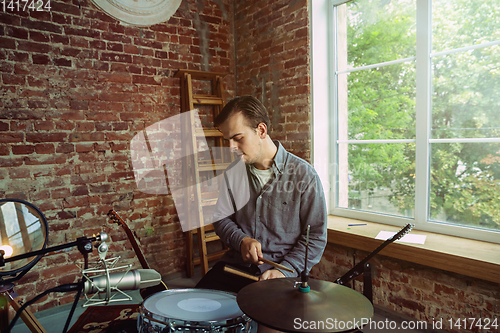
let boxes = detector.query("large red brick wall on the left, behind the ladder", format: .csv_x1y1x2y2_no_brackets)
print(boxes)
0,0,235,312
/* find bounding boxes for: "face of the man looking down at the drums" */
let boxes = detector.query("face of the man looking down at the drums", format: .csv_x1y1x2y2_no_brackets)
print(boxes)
219,112,265,164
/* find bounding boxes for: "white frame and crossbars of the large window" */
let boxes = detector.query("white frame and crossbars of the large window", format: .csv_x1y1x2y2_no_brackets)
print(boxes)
310,0,500,243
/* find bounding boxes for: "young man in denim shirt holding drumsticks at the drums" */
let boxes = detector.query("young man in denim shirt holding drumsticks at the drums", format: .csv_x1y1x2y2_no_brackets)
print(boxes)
197,96,327,292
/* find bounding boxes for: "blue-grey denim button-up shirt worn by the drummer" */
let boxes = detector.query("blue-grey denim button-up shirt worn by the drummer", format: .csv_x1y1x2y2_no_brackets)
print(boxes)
214,141,327,277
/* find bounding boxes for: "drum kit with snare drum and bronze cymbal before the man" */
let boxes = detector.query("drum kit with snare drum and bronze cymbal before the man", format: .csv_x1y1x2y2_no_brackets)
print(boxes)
137,224,413,333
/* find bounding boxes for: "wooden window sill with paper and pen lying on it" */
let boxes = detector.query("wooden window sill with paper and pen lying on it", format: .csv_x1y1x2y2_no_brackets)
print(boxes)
328,215,500,283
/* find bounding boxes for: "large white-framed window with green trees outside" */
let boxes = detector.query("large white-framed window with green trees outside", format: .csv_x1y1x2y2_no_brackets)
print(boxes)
312,0,500,242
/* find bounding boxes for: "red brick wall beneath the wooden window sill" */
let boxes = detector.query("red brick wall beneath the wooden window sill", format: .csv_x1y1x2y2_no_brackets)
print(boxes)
311,244,500,333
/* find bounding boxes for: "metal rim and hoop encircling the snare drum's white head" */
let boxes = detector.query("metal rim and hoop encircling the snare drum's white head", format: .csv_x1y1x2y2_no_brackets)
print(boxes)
139,288,251,328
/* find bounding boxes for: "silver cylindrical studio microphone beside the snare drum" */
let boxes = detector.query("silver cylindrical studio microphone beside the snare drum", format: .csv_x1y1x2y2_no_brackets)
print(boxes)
83,269,161,294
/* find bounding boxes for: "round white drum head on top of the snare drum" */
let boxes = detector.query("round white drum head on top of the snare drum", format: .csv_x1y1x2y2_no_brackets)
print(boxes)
143,289,243,322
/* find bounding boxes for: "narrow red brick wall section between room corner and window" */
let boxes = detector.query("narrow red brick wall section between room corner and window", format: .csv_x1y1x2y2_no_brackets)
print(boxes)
235,0,311,161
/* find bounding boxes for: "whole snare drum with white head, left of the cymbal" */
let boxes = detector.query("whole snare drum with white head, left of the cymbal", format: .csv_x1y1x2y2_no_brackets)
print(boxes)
137,289,250,333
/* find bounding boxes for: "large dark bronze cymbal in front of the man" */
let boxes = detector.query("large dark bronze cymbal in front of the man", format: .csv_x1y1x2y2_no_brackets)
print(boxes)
236,278,373,332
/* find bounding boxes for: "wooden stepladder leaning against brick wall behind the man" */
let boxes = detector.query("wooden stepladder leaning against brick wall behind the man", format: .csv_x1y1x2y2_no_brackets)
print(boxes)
175,69,233,277
